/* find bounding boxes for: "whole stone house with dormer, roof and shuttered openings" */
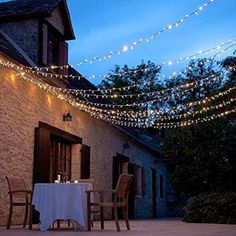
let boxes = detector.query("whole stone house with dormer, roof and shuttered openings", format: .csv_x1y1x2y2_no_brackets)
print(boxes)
0,0,169,225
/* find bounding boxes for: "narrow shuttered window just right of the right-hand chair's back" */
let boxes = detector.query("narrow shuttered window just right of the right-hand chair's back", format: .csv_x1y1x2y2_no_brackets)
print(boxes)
134,165,145,196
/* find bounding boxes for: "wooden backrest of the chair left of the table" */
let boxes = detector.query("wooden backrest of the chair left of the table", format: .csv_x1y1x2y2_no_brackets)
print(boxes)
6,176,27,197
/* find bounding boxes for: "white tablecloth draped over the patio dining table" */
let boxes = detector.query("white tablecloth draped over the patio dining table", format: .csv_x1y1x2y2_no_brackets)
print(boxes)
32,183,93,231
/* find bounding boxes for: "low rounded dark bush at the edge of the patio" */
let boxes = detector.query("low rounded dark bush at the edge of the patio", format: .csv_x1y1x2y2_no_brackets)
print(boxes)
184,192,236,224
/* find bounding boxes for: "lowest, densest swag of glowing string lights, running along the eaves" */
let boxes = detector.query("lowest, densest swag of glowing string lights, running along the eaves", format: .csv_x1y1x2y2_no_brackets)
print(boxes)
0,54,236,129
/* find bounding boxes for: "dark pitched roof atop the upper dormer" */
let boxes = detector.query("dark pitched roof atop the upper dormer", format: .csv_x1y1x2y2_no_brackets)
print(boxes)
0,0,75,40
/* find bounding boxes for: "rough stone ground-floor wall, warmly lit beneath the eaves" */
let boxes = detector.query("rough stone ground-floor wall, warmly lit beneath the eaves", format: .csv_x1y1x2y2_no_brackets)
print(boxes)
0,55,168,225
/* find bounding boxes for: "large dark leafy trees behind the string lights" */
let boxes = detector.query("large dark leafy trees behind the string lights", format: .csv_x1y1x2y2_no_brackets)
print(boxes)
100,56,236,196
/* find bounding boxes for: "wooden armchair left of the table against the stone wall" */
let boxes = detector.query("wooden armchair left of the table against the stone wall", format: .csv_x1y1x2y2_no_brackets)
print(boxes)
6,177,32,229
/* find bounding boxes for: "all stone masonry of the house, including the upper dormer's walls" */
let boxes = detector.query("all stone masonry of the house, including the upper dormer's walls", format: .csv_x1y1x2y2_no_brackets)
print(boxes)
0,0,171,225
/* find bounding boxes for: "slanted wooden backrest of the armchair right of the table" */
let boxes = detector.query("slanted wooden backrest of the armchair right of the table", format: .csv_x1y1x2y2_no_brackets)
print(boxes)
116,174,133,200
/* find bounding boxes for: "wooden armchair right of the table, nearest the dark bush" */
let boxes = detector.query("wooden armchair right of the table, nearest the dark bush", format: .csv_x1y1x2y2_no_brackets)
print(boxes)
86,174,133,231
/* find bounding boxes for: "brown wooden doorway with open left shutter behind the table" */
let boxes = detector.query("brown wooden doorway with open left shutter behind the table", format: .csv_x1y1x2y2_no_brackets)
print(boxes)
33,122,82,184
